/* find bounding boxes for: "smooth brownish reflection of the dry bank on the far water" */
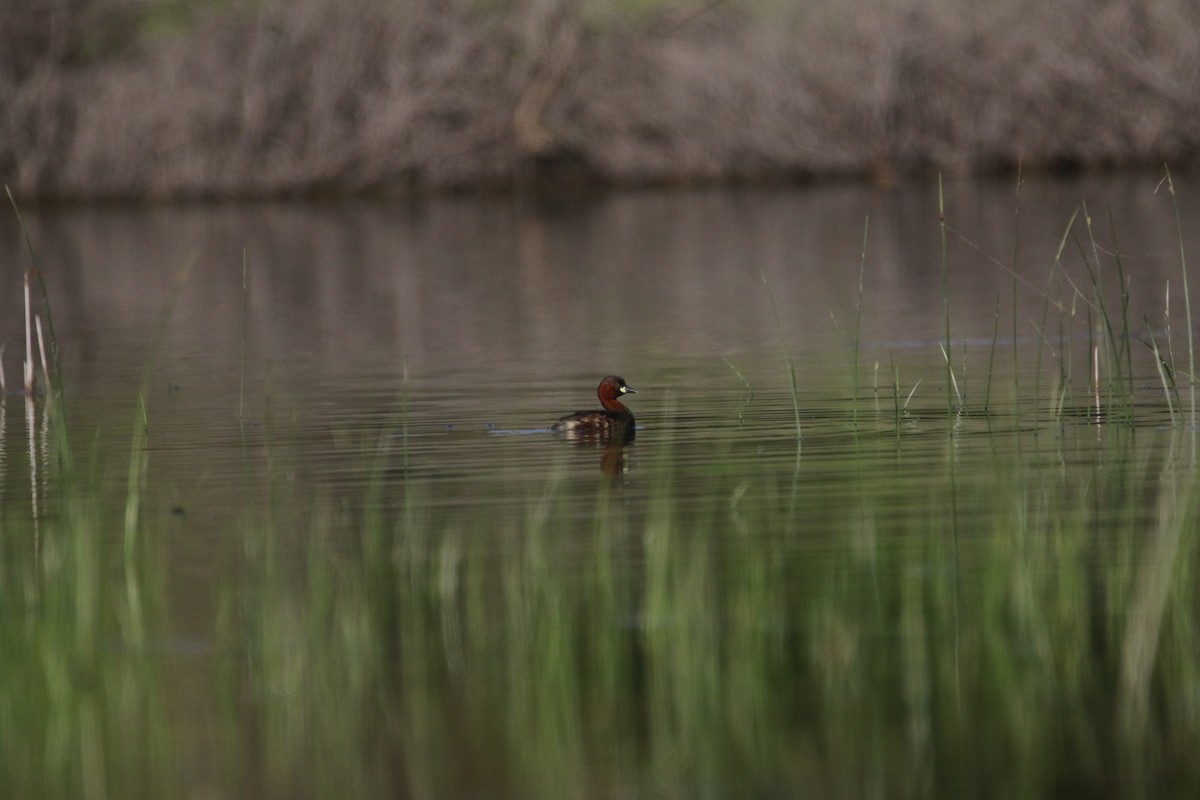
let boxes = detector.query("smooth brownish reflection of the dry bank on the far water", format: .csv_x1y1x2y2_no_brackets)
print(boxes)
0,176,1194,388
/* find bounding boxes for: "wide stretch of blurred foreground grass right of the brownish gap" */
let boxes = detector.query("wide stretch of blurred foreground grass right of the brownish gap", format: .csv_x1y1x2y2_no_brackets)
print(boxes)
211,431,1200,798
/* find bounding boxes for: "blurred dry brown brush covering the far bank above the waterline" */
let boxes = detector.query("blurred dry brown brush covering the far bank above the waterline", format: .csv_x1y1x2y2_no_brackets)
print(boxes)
0,0,1200,198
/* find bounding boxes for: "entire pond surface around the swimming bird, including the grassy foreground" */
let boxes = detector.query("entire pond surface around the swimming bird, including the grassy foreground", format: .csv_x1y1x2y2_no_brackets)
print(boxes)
0,175,1200,798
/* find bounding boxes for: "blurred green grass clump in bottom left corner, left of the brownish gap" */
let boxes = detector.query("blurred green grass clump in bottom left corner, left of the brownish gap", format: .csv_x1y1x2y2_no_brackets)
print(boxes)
0,410,180,798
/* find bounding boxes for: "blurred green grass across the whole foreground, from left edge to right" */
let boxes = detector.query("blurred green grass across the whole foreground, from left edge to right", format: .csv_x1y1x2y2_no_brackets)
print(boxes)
0,410,1200,798
